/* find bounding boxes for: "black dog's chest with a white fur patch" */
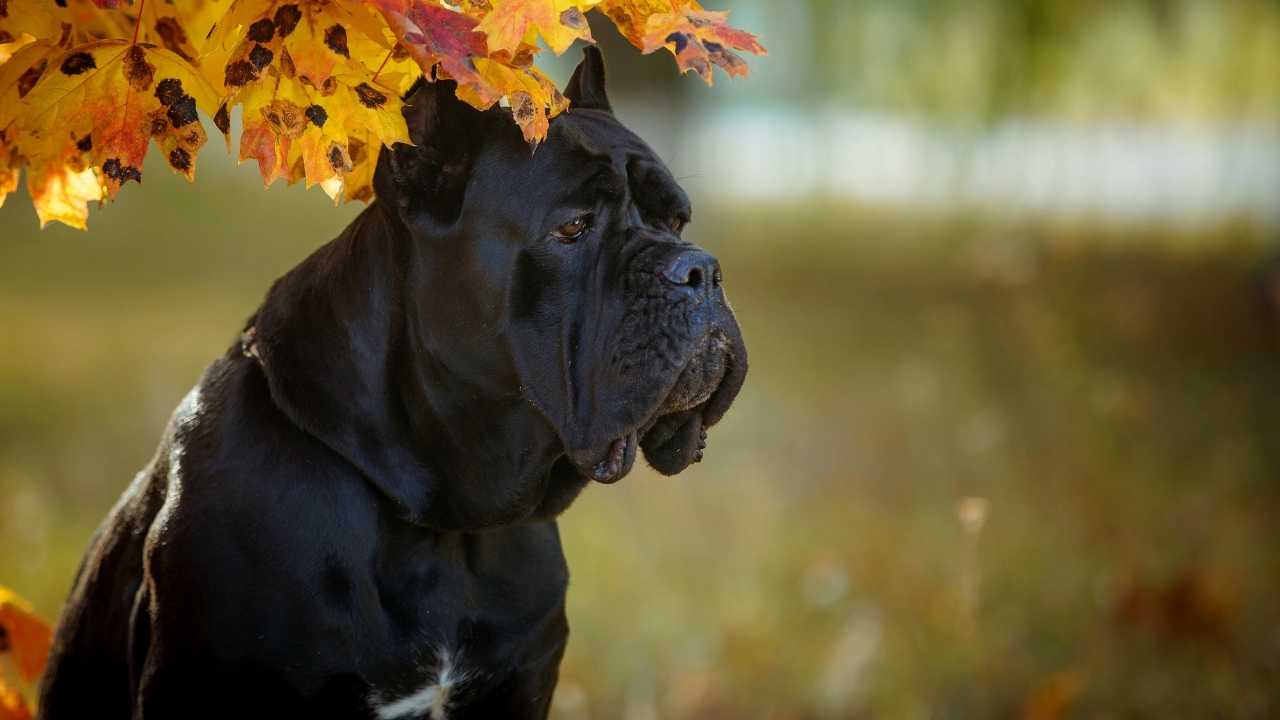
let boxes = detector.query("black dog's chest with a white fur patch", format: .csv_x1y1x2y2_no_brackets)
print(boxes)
355,520,567,720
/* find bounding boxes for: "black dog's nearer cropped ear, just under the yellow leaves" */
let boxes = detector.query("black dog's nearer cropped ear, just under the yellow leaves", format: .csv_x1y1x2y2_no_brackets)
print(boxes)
374,78,492,228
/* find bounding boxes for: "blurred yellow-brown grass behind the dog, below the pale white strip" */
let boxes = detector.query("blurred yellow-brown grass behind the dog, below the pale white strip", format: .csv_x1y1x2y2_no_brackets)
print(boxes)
0,161,1280,720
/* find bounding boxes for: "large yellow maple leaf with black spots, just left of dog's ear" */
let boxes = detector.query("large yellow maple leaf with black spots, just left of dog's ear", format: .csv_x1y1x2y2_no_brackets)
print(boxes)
202,0,419,201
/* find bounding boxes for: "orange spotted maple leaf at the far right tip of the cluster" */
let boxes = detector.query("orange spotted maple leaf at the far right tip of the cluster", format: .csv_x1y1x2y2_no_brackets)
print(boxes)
641,9,767,85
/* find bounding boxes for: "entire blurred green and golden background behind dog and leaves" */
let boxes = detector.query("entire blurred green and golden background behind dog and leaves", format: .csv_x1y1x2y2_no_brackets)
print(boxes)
0,0,1280,720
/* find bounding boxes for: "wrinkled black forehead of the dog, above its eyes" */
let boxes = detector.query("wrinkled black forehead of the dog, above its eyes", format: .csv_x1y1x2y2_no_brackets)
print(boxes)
473,110,689,215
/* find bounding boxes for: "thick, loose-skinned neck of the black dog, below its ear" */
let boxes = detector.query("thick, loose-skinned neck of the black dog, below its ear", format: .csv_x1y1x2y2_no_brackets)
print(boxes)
242,201,585,530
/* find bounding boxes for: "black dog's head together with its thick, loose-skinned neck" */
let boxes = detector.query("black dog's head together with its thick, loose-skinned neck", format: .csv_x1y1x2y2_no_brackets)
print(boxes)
249,49,746,524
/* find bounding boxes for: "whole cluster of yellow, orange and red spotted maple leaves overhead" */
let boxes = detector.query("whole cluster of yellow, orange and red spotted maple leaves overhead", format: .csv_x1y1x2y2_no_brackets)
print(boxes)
0,0,764,228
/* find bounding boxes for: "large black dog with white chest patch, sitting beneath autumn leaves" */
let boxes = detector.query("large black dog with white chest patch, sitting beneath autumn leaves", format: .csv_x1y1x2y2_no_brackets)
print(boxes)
41,50,746,720
